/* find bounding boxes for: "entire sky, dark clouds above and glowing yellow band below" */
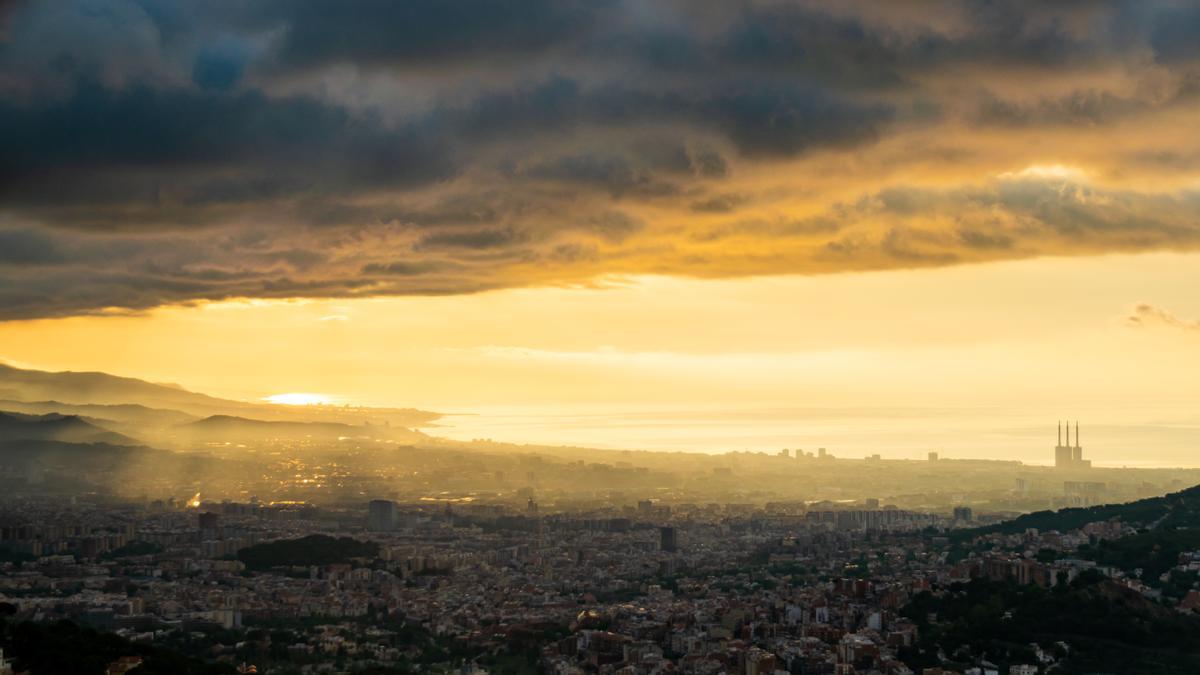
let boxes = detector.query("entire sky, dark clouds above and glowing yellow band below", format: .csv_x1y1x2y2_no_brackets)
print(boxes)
0,0,1200,456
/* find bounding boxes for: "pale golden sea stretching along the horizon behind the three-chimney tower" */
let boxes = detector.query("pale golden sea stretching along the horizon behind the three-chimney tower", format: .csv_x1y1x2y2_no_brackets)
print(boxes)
422,406,1200,467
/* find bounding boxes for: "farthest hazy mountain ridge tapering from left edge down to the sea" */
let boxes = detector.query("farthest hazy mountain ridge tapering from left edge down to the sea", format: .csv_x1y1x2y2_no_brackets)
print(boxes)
0,364,440,426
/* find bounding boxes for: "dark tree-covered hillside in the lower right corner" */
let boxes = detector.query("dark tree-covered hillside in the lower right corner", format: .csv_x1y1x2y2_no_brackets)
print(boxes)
904,488,1200,674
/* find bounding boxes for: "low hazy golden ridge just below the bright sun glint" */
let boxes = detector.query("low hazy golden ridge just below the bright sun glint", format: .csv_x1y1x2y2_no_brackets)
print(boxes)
175,414,425,442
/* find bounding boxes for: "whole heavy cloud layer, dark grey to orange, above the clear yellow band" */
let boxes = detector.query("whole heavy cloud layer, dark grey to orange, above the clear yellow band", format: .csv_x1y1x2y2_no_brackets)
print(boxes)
0,0,1200,318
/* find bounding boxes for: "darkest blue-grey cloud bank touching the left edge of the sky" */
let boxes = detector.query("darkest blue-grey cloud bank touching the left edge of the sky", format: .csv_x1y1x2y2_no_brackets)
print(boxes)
0,71,455,212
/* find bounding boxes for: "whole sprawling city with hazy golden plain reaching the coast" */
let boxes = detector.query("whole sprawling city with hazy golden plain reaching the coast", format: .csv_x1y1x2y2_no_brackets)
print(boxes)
0,369,1200,675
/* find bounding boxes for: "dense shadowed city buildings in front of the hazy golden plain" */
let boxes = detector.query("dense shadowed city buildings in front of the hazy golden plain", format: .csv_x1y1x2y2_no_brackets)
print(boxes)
7,473,1200,674
